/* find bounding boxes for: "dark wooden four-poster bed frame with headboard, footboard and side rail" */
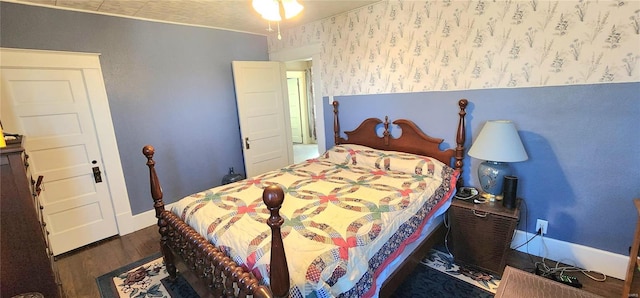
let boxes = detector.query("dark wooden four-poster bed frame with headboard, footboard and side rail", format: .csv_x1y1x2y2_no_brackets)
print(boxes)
142,99,468,297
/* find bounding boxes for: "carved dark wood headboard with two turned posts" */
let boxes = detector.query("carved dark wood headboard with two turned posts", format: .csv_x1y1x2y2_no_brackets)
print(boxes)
333,99,469,187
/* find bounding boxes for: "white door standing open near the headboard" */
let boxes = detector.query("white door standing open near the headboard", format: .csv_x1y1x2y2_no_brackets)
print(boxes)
232,61,293,177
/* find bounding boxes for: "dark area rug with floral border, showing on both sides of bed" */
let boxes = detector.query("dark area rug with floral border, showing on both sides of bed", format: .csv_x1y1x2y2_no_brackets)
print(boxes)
97,249,500,298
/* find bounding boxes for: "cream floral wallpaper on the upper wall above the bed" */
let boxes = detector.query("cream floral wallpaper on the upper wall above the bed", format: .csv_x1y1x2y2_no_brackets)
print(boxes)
268,0,640,96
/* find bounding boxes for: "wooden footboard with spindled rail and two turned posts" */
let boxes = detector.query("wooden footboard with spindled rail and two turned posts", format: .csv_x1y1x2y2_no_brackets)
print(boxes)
142,145,289,297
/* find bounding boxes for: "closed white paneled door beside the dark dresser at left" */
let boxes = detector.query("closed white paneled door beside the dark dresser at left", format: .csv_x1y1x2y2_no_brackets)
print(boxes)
0,48,118,255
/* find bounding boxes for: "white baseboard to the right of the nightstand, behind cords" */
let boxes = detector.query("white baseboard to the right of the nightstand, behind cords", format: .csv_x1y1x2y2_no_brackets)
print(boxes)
511,230,629,280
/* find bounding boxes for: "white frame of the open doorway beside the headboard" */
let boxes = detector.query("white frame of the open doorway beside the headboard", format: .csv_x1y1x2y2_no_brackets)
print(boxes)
269,43,327,154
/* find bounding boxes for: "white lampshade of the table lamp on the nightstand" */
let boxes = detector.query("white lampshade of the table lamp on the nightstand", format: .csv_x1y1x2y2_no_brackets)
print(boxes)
469,120,529,162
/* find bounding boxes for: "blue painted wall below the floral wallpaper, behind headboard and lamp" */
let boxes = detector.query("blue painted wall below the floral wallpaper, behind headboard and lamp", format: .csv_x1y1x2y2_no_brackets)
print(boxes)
324,83,640,254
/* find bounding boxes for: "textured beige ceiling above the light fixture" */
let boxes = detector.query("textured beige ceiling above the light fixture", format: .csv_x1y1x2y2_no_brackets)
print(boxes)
10,0,380,35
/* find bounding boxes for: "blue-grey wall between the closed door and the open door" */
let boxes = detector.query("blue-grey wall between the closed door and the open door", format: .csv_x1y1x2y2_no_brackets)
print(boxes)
0,2,268,214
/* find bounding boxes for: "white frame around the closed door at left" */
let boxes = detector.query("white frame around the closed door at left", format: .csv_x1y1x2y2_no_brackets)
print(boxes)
0,48,136,235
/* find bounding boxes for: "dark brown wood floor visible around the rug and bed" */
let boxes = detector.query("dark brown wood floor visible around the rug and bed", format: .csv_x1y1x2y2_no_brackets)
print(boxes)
56,226,623,298
